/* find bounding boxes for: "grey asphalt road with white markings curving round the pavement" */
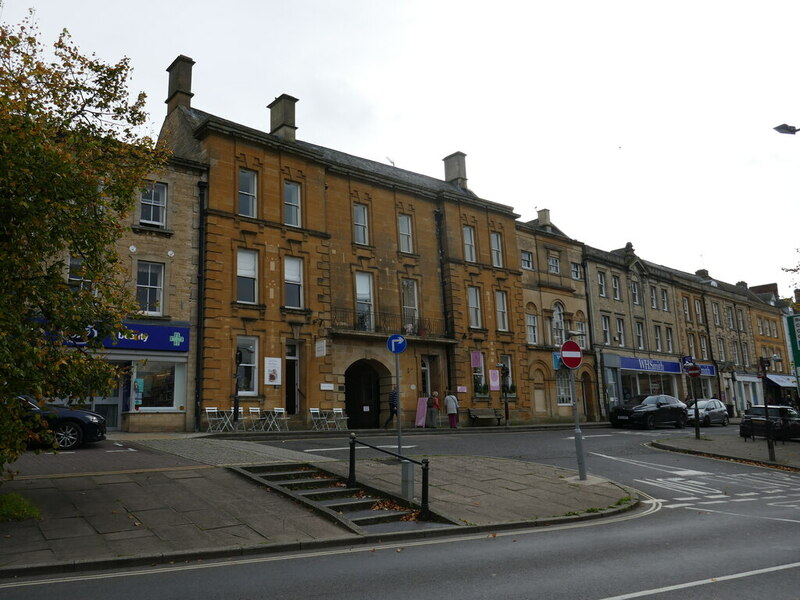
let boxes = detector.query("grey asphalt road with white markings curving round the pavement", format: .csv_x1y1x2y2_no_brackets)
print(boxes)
0,427,800,600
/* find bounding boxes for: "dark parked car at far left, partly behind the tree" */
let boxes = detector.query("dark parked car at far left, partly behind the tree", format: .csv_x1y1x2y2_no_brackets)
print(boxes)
20,397,106,450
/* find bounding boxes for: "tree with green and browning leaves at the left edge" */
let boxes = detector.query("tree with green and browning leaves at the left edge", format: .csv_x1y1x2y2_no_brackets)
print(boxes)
0,17,164,480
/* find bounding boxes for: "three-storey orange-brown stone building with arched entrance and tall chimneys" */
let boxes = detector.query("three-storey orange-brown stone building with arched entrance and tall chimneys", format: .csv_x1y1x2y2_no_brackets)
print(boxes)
161,56,524,428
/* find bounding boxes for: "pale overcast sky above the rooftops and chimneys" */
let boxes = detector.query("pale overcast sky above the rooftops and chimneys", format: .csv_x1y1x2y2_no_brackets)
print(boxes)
6,0,800,296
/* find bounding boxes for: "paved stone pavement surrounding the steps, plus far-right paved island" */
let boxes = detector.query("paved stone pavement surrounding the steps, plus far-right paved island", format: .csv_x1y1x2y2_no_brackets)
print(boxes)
0,424,800,578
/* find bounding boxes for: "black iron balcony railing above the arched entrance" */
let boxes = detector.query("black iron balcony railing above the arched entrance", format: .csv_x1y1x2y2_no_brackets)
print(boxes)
331,308,453,338
